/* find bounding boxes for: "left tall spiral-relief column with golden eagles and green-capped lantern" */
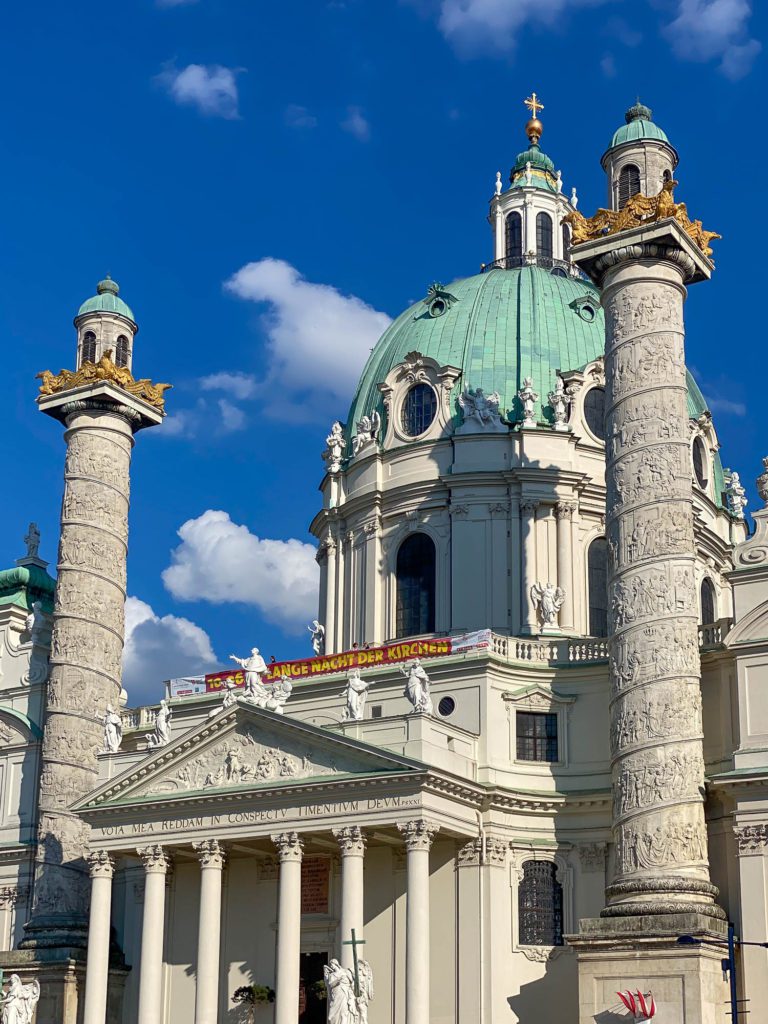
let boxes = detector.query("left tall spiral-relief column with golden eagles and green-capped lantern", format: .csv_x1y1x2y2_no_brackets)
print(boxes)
23,280,165,950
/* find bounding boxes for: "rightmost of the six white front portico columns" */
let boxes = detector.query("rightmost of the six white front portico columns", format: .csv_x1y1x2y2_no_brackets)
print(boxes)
397,819,438,1024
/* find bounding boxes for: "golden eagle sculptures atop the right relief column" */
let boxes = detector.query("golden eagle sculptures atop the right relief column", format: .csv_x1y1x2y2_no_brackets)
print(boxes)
561,178,722,256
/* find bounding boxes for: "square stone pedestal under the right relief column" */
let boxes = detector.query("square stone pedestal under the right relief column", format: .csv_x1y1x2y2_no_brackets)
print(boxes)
565,912,728,1024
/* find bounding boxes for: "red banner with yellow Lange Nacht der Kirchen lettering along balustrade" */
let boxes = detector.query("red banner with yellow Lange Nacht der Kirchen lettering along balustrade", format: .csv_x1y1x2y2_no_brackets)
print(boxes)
170,630,490,697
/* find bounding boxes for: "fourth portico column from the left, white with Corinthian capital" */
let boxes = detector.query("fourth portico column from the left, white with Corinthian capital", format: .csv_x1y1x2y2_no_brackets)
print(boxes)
272,833,304,1024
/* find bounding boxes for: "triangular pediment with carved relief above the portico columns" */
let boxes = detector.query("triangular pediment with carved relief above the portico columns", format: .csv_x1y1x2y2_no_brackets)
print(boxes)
74,701,426,810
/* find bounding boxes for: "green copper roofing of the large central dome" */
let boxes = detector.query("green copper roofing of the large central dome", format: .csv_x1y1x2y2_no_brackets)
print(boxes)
347,266,725,501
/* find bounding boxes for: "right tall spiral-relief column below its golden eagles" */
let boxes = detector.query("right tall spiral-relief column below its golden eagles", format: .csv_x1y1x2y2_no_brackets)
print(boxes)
573,193,724,1021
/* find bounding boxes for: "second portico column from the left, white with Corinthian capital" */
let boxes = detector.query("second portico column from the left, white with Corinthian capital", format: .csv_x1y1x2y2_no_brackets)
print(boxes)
136,846,170,1024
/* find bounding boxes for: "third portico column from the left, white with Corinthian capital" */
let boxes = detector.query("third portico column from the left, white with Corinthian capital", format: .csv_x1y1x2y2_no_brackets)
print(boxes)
193,839,224,1024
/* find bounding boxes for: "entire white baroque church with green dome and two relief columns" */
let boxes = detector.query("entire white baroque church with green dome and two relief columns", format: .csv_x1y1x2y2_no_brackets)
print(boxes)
0,94,768,1024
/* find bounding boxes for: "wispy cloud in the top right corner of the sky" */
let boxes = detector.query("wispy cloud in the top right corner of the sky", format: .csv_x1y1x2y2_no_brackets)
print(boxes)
666,0,762,79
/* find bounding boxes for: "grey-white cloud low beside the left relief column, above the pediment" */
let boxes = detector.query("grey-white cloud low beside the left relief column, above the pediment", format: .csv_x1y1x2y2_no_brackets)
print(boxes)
123,597,219,706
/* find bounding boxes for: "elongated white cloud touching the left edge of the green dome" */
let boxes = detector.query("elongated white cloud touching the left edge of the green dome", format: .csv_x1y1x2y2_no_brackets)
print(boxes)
224,258,390,420
